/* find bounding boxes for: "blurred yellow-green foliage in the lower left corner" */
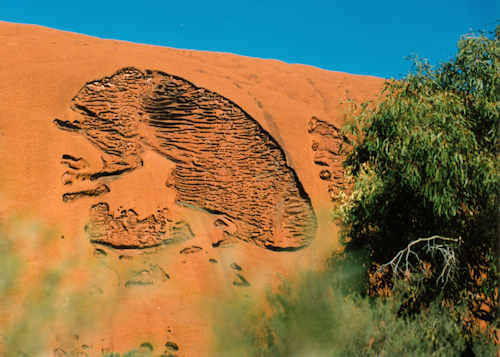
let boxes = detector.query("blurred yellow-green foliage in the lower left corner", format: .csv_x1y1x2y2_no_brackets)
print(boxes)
0,218,170,357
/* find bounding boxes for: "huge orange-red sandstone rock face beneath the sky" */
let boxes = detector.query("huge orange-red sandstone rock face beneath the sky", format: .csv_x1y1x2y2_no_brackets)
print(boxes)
0,23,383,356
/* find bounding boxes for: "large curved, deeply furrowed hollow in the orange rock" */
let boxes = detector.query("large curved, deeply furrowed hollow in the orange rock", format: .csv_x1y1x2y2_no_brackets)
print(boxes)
55,68,316,250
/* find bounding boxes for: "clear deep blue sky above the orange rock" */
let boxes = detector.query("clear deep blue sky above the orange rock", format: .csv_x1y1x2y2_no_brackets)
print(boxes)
0,0,500,78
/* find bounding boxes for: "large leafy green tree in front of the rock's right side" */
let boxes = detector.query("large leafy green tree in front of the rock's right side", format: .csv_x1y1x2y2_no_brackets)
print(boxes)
340,26,500,312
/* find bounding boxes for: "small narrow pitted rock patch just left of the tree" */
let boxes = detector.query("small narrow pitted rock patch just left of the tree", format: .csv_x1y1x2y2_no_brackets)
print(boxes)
307,117,347,200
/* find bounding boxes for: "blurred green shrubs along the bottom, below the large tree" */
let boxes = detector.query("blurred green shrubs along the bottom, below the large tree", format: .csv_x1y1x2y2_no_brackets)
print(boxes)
214,253,495,357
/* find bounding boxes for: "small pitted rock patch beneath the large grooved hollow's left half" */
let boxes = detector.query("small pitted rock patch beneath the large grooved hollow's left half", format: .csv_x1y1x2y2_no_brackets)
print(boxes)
86,202,194,249
